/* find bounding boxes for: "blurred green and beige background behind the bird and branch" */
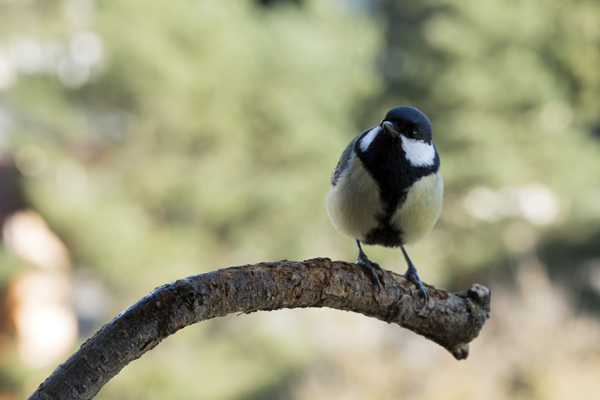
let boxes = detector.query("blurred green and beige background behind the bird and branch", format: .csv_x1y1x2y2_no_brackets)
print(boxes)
0,0,600,400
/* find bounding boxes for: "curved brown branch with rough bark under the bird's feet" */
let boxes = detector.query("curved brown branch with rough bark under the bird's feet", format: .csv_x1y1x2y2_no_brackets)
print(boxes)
29,258,490,399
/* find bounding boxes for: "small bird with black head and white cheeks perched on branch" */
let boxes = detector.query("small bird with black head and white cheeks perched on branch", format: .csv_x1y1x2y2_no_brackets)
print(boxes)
325,106,444,304
